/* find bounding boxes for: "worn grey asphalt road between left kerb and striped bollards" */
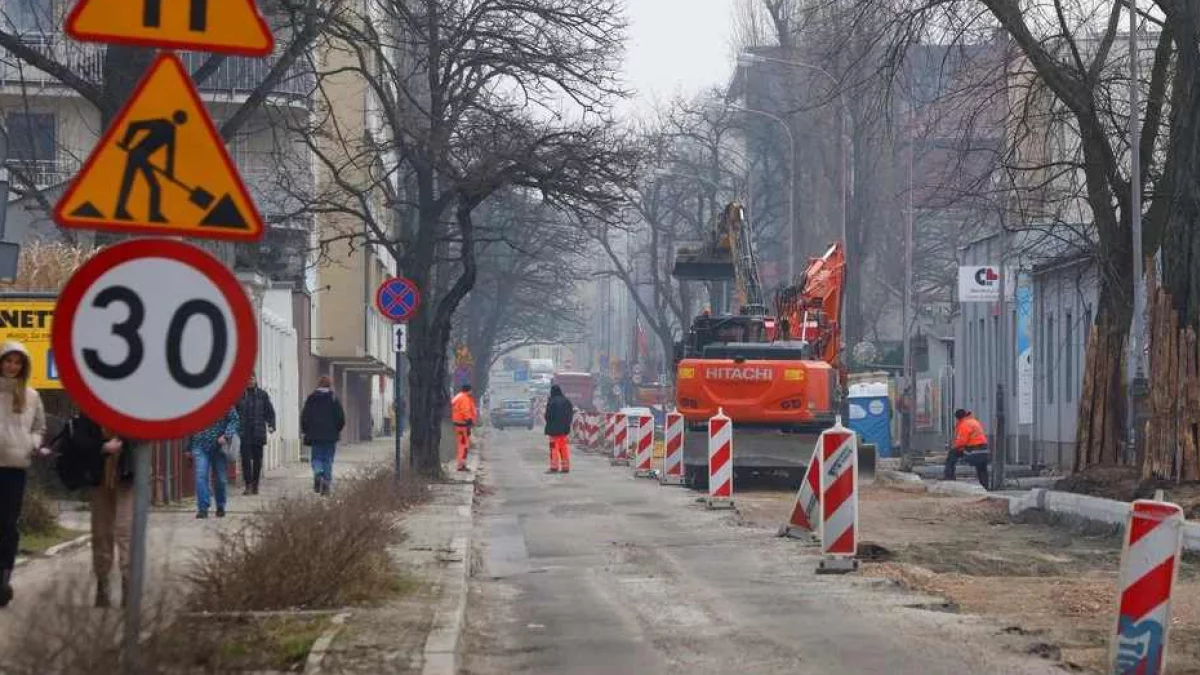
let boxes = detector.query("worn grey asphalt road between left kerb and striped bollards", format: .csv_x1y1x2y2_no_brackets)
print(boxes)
463,431,1062,675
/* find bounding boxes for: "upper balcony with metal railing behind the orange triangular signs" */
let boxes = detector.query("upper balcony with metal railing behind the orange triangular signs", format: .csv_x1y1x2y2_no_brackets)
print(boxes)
0,34,316,102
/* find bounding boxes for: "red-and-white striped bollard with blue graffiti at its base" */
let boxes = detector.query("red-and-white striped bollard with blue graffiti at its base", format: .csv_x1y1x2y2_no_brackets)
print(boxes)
1109,500,1183,675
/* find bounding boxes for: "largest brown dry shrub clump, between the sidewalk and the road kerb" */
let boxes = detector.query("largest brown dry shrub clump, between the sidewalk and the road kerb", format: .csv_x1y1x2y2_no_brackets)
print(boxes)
186,470,427,611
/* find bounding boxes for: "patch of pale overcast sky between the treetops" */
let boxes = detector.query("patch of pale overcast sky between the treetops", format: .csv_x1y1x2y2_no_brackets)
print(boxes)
620,0,733,115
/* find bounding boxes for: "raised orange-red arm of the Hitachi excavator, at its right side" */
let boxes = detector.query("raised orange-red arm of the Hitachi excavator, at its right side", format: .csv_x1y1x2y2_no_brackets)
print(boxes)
775,241,846,371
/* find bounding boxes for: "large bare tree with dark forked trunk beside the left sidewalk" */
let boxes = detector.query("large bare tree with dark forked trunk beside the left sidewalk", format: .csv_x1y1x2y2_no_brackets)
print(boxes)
283,0,635,476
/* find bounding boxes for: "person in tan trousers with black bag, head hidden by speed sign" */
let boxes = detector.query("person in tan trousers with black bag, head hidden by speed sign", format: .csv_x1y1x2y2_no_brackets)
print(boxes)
66,414,136,607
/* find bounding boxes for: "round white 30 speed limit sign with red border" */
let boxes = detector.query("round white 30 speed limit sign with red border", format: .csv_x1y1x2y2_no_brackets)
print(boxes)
52,239,258,440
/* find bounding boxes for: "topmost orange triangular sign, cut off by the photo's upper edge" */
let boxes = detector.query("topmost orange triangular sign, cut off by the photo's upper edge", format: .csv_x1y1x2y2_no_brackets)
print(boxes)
66,0,275,56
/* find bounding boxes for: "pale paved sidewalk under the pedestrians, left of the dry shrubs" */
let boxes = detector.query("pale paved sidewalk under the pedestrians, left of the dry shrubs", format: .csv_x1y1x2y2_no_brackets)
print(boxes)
0,437,395,653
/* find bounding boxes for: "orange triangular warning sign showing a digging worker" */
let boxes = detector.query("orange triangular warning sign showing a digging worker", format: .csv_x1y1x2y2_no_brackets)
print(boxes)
54,53,263,241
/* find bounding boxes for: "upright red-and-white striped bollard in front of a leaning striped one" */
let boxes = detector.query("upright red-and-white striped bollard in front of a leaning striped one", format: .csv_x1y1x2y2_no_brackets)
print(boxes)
817,416,858,574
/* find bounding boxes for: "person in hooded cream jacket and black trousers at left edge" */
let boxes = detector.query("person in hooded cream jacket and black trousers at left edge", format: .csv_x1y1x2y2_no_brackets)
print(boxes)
0,342,46,607
